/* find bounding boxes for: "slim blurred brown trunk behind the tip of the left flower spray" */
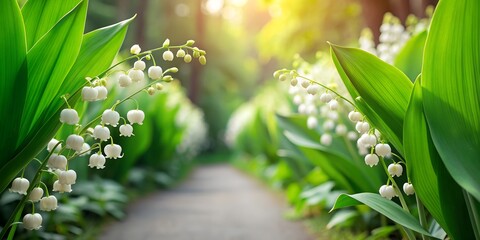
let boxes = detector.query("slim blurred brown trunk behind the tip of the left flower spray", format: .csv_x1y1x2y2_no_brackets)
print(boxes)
188,0,205,105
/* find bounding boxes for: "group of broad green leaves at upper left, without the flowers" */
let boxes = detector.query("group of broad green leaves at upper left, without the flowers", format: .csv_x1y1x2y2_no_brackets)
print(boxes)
0,0,131,191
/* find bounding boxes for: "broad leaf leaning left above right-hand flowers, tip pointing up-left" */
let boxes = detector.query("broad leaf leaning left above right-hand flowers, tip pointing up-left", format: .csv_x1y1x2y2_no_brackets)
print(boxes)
331,45,413,156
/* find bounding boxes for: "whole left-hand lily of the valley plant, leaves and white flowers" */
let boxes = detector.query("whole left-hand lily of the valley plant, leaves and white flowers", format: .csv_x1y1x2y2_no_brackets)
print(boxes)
0,0,206,239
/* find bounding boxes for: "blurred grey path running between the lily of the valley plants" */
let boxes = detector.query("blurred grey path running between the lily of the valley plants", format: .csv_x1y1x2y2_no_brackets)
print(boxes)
100,165,314,240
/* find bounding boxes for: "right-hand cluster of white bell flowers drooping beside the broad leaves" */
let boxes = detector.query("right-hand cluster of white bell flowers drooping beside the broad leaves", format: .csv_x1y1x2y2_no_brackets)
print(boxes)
274,55,414,202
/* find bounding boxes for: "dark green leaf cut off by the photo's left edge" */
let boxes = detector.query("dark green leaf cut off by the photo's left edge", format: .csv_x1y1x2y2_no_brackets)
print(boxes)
0,0,28,167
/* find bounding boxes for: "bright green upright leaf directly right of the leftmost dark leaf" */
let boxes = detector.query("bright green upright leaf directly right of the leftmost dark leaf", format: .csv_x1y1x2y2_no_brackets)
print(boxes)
18,1,88,144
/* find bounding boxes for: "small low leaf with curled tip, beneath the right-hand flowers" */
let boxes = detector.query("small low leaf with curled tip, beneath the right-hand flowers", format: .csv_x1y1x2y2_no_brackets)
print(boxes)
330,193,431,236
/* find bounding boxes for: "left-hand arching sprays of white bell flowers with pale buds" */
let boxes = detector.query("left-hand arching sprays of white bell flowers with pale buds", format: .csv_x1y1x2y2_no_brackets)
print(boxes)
9,39,206,230
